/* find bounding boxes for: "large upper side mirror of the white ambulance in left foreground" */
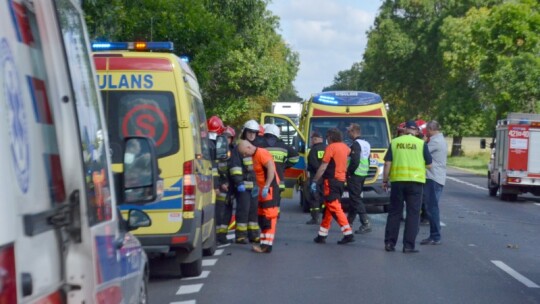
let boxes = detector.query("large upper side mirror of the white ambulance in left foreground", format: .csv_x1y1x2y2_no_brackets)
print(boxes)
122,137,163,204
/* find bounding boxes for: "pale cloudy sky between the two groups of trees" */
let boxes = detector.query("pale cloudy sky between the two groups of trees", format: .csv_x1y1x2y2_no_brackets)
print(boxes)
268,0,382,99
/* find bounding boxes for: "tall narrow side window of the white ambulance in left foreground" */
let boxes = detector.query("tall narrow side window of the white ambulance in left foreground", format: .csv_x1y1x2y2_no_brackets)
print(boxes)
56,0,113,225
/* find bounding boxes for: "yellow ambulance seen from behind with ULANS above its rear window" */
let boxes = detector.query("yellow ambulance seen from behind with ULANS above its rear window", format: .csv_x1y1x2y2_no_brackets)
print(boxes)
92,42,216,276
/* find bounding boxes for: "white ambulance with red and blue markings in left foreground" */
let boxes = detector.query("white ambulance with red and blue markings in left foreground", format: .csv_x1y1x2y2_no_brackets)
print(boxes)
0,0,160,304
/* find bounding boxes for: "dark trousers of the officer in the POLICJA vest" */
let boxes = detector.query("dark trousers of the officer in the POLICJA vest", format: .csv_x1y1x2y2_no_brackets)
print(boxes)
384,182,424,248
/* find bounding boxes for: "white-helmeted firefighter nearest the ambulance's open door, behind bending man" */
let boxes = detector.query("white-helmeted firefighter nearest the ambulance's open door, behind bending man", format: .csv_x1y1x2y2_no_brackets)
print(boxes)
261,124,300,208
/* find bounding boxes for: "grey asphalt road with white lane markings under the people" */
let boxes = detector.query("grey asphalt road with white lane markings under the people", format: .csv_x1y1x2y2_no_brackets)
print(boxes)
149,170,540,304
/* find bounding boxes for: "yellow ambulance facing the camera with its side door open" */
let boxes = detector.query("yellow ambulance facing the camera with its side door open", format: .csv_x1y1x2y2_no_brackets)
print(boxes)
261,91,391,212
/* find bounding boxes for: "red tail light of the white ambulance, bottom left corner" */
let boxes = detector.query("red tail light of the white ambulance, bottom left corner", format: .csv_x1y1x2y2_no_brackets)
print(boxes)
0,244,17,303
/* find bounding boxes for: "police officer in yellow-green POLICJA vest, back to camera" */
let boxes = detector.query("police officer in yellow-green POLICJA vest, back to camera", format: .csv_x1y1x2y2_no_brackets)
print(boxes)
383,120,432,253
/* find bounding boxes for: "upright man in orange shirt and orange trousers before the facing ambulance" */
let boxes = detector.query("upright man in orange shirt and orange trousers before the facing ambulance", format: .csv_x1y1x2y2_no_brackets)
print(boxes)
310,128,354,244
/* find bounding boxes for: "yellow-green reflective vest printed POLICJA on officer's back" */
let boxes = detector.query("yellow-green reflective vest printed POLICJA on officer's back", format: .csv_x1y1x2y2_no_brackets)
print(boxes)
390,135,426,183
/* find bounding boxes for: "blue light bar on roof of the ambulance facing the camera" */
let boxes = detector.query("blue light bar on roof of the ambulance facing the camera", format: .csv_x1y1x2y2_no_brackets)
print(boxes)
312,91,382,106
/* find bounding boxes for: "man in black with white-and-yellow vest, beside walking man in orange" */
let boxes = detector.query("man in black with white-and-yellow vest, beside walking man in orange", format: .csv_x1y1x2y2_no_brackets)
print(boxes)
347,123,371,234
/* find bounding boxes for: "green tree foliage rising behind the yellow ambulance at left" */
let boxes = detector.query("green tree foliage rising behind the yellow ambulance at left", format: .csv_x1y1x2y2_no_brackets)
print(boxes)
84,0,299,125
